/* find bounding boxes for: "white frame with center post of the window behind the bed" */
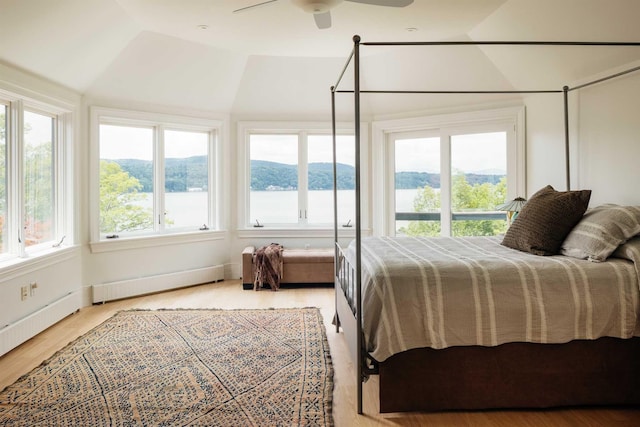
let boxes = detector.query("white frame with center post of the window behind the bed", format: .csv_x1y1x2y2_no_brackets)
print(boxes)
372,106,526,236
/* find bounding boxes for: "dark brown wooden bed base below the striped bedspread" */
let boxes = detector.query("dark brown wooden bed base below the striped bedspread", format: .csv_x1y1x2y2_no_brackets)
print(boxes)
379,338,640,412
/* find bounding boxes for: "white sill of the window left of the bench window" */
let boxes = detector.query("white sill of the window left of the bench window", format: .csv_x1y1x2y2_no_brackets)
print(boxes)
89,231,227,254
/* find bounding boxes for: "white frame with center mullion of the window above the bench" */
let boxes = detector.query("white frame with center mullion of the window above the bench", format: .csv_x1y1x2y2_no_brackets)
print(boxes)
236,121,369,237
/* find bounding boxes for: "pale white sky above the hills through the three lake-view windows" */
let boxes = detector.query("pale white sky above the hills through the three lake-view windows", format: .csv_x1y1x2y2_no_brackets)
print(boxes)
100,125,507,173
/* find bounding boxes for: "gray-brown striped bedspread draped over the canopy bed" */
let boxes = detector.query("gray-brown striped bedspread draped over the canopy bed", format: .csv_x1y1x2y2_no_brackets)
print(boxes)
345,237,640,362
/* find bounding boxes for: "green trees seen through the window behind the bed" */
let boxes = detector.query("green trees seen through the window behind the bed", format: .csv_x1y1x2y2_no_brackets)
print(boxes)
400,173,507,236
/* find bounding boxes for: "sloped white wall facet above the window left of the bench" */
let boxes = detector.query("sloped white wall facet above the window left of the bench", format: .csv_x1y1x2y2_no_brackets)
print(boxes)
85,31,247,113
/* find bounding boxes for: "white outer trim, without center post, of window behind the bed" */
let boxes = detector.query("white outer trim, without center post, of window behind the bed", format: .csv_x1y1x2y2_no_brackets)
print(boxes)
371,106,526,236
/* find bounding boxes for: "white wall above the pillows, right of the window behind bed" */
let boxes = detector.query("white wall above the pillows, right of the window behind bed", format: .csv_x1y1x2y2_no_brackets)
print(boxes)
525,64,640,207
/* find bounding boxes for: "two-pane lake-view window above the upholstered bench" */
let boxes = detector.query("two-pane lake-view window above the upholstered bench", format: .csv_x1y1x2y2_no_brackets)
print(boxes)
239,126,355,228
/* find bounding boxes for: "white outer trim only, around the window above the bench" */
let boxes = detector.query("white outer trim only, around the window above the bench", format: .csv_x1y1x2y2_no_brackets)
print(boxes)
236,121,370,238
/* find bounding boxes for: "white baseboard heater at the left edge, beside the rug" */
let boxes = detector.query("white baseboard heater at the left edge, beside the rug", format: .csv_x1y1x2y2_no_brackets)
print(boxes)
0,290,82,356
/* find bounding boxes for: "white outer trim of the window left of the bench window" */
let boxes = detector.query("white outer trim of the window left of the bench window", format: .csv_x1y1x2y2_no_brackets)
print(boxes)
89,106,227,253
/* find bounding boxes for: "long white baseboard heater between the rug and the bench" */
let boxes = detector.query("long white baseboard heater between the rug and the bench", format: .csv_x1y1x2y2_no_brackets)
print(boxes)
92,265,224,304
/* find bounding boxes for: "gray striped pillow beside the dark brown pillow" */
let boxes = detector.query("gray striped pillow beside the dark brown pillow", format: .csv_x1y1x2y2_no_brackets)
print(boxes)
560,205,640,262
